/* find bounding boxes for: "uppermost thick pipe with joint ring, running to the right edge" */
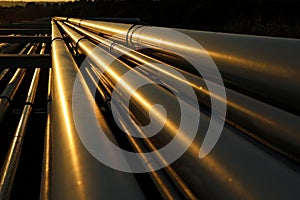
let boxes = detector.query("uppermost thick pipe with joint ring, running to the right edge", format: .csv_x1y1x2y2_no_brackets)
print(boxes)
62,18,300,114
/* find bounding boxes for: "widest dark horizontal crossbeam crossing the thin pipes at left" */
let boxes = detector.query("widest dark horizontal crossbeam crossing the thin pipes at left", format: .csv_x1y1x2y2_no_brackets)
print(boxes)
0,54,51,69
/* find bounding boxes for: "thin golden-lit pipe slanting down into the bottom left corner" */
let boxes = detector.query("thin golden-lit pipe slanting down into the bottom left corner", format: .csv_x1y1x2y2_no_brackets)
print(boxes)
0,44,46,200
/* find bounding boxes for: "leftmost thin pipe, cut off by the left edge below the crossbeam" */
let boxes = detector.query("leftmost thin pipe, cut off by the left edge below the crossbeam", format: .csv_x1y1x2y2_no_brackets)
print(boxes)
0,43,37,124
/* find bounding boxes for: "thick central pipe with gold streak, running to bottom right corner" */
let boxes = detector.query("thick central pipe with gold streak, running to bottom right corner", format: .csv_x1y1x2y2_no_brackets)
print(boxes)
60,19,300,199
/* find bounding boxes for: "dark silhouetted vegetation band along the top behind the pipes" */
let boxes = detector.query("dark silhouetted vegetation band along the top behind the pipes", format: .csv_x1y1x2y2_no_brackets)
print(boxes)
0,0,300,38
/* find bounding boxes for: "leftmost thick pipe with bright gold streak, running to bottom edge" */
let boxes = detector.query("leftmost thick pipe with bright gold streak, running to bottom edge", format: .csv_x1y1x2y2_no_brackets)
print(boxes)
49,21,145,199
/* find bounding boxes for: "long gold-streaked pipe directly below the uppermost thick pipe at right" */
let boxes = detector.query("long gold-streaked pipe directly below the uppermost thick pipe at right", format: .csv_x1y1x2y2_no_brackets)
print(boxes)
66,22,300,161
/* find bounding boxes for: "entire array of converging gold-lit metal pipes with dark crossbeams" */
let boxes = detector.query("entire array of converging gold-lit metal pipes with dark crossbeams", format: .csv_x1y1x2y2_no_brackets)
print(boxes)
0,17,300,200
